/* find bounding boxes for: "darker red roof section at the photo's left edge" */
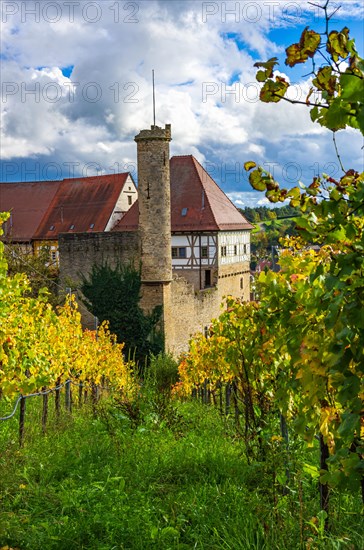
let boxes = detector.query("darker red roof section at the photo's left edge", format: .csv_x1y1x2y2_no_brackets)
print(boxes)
0,181,61,242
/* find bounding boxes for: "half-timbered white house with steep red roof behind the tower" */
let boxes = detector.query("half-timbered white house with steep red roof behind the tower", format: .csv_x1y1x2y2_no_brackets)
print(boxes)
114,155,252,299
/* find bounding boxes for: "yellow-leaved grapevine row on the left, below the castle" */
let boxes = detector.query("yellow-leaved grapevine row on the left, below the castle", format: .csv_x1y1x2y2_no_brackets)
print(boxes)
0,214,135,404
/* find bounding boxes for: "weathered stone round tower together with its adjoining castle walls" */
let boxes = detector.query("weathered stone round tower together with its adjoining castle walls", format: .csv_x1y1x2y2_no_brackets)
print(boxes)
59,125,250,356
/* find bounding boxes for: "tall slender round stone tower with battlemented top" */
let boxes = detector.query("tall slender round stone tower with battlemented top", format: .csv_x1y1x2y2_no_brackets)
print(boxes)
135,124,172,349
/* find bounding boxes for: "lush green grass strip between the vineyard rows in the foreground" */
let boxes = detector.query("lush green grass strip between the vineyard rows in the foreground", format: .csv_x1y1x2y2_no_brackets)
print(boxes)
0,392,363,550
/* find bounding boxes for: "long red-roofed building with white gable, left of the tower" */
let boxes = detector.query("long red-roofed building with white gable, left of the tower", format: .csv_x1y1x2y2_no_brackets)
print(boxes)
0,173,138,264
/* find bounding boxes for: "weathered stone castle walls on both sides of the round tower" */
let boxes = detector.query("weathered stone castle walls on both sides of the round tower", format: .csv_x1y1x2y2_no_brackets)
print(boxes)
59,232,250,357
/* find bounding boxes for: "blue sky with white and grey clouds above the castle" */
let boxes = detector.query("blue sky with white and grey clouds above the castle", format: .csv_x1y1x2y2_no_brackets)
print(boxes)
0,0,363,206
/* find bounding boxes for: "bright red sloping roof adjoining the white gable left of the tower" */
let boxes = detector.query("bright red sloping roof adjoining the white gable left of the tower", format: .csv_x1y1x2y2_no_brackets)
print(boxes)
34,173,129,239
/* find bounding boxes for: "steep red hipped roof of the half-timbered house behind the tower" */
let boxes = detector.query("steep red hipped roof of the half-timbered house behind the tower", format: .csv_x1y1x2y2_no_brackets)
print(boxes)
113,155,253,233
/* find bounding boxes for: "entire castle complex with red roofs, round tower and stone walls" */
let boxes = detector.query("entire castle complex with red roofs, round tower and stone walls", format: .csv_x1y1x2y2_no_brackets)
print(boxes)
0,124,253,356
